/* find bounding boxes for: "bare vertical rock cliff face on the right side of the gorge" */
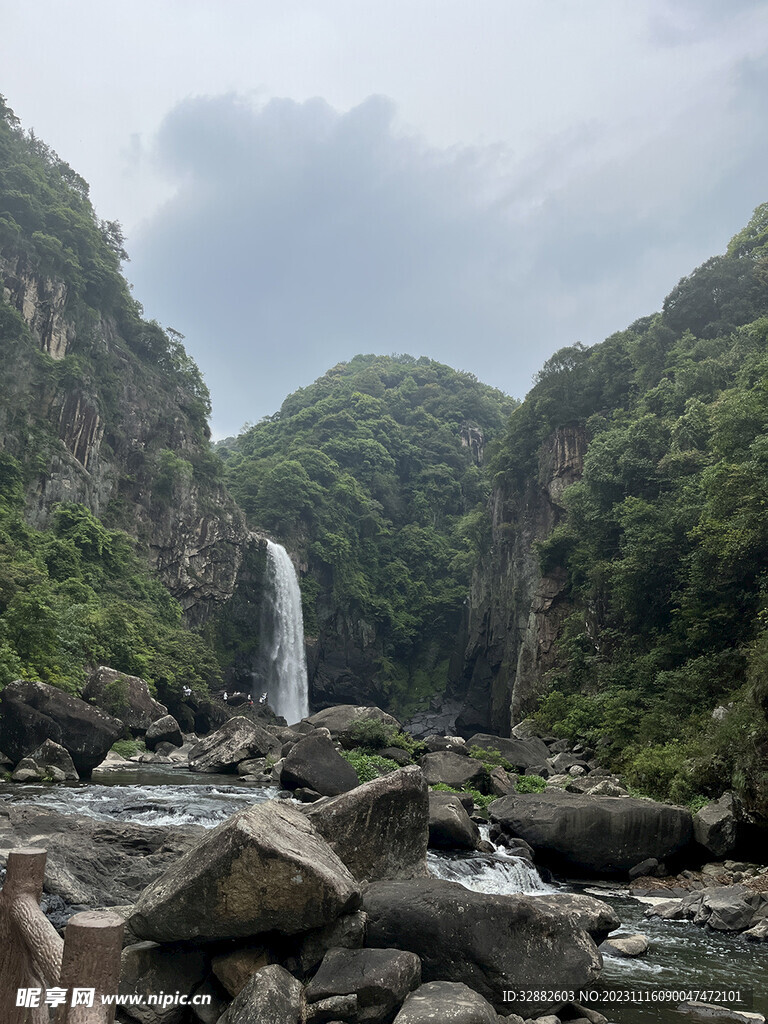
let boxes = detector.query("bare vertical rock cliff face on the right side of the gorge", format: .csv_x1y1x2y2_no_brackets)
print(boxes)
457,427,586,734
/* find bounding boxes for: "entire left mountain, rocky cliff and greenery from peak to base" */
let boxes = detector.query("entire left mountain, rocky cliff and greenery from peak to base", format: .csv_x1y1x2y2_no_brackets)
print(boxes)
0,97,240,694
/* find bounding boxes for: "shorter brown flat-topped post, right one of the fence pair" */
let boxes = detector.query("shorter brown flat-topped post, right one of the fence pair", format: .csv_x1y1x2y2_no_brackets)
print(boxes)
59,910,123,1024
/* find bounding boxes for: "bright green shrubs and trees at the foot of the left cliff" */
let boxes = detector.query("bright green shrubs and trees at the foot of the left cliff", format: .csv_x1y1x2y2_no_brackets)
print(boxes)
0,454,220,698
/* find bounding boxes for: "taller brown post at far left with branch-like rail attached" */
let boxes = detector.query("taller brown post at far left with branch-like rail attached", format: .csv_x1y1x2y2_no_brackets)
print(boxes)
0,849,63,1024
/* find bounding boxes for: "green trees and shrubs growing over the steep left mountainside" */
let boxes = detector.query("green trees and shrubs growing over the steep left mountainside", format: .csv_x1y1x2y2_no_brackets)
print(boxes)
0,97,225,696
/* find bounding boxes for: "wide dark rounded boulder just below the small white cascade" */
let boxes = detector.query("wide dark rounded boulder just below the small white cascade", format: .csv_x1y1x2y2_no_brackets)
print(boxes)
364,879,602,1012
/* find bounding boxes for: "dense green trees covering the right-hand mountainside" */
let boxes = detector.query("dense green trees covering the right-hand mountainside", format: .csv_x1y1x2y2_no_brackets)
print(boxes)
495,204,768,812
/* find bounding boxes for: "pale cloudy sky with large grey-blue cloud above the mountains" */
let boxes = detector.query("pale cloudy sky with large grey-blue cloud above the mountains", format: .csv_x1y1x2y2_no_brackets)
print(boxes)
0,0,768,437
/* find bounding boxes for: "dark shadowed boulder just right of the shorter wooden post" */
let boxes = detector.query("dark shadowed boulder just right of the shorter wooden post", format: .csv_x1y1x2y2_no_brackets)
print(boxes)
119,942,209,1024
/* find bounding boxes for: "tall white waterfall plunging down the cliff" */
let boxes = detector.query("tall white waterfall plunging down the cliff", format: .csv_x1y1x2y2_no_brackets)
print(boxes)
256,541,309,725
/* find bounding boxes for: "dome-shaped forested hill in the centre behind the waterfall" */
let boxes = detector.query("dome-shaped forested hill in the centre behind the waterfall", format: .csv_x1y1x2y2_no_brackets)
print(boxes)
222,355,514,707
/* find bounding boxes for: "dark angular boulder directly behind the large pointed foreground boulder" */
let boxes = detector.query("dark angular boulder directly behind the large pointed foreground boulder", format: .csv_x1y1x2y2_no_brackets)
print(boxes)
303,770,429,882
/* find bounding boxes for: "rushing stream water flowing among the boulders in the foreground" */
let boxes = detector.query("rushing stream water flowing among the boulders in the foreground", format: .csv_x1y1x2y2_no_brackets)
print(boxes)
0,765,768,1024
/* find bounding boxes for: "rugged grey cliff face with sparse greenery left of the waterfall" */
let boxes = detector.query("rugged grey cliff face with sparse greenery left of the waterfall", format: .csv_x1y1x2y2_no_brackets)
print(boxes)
0,251,248,625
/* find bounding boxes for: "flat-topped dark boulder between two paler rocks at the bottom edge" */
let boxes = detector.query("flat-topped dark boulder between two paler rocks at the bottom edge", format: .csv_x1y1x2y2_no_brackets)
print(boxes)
304,949,421,1024
